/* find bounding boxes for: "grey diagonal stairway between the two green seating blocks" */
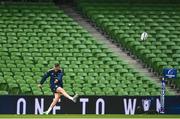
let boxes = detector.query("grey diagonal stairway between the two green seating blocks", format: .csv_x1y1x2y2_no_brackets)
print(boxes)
60,5,177,95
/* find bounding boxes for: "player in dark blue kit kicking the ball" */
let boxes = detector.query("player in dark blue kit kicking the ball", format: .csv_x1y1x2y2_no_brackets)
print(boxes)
38,64,78,114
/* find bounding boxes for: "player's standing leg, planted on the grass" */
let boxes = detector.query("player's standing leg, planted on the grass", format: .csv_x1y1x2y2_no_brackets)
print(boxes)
45,93,60,114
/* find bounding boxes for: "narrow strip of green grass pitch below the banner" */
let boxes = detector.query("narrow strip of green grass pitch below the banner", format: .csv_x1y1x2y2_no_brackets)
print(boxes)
0,114,180,119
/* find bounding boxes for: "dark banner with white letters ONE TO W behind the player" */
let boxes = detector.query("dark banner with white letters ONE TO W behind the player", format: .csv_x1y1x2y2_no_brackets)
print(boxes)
0,96,180,115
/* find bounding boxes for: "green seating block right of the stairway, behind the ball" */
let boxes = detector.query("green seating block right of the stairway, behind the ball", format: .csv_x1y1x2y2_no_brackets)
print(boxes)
77,0,180,90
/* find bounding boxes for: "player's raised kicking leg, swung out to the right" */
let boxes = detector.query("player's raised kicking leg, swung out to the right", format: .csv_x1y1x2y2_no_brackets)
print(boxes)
56,87,78,102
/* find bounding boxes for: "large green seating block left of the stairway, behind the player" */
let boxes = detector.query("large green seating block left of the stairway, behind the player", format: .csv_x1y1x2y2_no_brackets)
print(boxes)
0,3,173,95
